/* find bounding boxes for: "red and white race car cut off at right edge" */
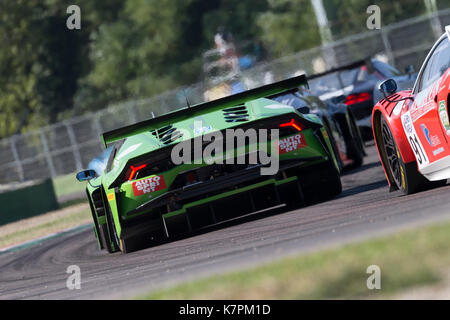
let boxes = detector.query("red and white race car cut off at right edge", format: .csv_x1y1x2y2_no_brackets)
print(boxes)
372,26,450,194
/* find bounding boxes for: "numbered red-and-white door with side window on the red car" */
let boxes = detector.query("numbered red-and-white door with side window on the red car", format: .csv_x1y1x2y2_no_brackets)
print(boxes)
402,37,450,170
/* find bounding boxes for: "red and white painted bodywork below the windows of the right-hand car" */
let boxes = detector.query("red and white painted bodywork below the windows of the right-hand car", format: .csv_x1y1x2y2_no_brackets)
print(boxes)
372,68,450,190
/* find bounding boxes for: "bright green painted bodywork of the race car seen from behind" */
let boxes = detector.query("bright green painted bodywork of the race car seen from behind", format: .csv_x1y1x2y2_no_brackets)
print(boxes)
80,76,340,252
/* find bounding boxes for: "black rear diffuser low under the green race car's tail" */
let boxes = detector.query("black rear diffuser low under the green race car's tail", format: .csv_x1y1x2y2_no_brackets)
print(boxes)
120,177,303,239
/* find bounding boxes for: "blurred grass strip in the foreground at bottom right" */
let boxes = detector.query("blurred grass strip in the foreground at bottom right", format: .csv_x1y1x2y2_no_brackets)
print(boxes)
137,223,450,299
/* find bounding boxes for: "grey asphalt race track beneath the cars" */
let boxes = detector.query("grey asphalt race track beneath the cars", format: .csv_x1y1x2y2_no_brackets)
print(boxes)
0,146,450,299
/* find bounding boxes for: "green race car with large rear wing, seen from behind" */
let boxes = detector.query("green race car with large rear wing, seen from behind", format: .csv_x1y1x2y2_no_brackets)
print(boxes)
77,75,348,253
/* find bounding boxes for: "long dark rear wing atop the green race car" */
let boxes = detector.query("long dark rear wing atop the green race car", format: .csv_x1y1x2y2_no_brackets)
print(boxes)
102,74,308,148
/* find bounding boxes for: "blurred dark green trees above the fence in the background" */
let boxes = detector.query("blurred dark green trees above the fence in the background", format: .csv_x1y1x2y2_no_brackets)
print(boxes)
0,0,430,138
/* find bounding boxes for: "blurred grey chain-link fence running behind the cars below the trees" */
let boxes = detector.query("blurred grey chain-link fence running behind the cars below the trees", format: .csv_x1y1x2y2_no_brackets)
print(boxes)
0,9,450,184
